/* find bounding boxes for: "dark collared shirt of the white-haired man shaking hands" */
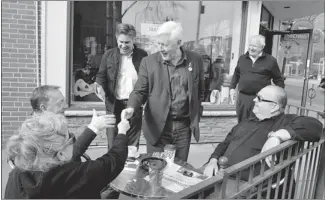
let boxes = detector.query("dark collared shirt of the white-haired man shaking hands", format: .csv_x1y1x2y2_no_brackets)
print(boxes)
164,49,189,119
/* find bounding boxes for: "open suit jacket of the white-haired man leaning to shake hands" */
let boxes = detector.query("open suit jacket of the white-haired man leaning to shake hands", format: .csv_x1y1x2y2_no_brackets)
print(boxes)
128,50,204,145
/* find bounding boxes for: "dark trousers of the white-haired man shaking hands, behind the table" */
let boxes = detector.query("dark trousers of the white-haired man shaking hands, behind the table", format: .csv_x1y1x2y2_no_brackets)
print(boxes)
147,118,191,162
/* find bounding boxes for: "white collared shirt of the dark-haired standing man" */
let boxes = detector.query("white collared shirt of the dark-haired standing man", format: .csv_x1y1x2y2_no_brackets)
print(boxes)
115,54,138,100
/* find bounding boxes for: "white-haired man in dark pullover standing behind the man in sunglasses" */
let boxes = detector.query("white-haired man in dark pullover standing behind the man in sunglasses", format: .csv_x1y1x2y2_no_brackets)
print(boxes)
230,35,284,123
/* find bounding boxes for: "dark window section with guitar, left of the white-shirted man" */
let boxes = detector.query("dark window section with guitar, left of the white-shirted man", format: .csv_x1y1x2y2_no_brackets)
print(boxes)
71,1,107,102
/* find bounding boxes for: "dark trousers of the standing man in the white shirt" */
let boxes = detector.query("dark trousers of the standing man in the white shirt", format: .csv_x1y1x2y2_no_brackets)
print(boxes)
106,100,142,149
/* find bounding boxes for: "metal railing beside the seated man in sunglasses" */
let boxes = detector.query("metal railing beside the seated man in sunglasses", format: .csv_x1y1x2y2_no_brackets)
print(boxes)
171,105,325,199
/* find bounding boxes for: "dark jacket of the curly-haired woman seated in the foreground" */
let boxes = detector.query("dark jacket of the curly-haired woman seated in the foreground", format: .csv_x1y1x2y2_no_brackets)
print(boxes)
4,128,128,199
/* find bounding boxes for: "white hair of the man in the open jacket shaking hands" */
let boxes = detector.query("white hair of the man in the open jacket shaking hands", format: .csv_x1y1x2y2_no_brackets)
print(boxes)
156,21,183,41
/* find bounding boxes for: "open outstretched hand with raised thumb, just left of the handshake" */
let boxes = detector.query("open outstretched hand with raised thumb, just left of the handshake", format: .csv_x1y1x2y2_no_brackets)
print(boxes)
88,109,116,134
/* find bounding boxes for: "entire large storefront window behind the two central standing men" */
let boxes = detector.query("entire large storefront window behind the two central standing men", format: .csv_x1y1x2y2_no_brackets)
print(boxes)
72,1,242,105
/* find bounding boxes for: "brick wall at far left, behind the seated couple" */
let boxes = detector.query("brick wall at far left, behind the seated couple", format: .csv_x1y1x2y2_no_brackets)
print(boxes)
1,1,39,142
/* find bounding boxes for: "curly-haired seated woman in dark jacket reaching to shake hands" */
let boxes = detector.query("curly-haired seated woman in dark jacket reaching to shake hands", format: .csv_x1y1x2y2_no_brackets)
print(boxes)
5,113,130,199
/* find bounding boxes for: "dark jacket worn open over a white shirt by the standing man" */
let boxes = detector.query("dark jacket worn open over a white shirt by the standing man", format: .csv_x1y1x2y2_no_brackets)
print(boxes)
96,46,148,112
